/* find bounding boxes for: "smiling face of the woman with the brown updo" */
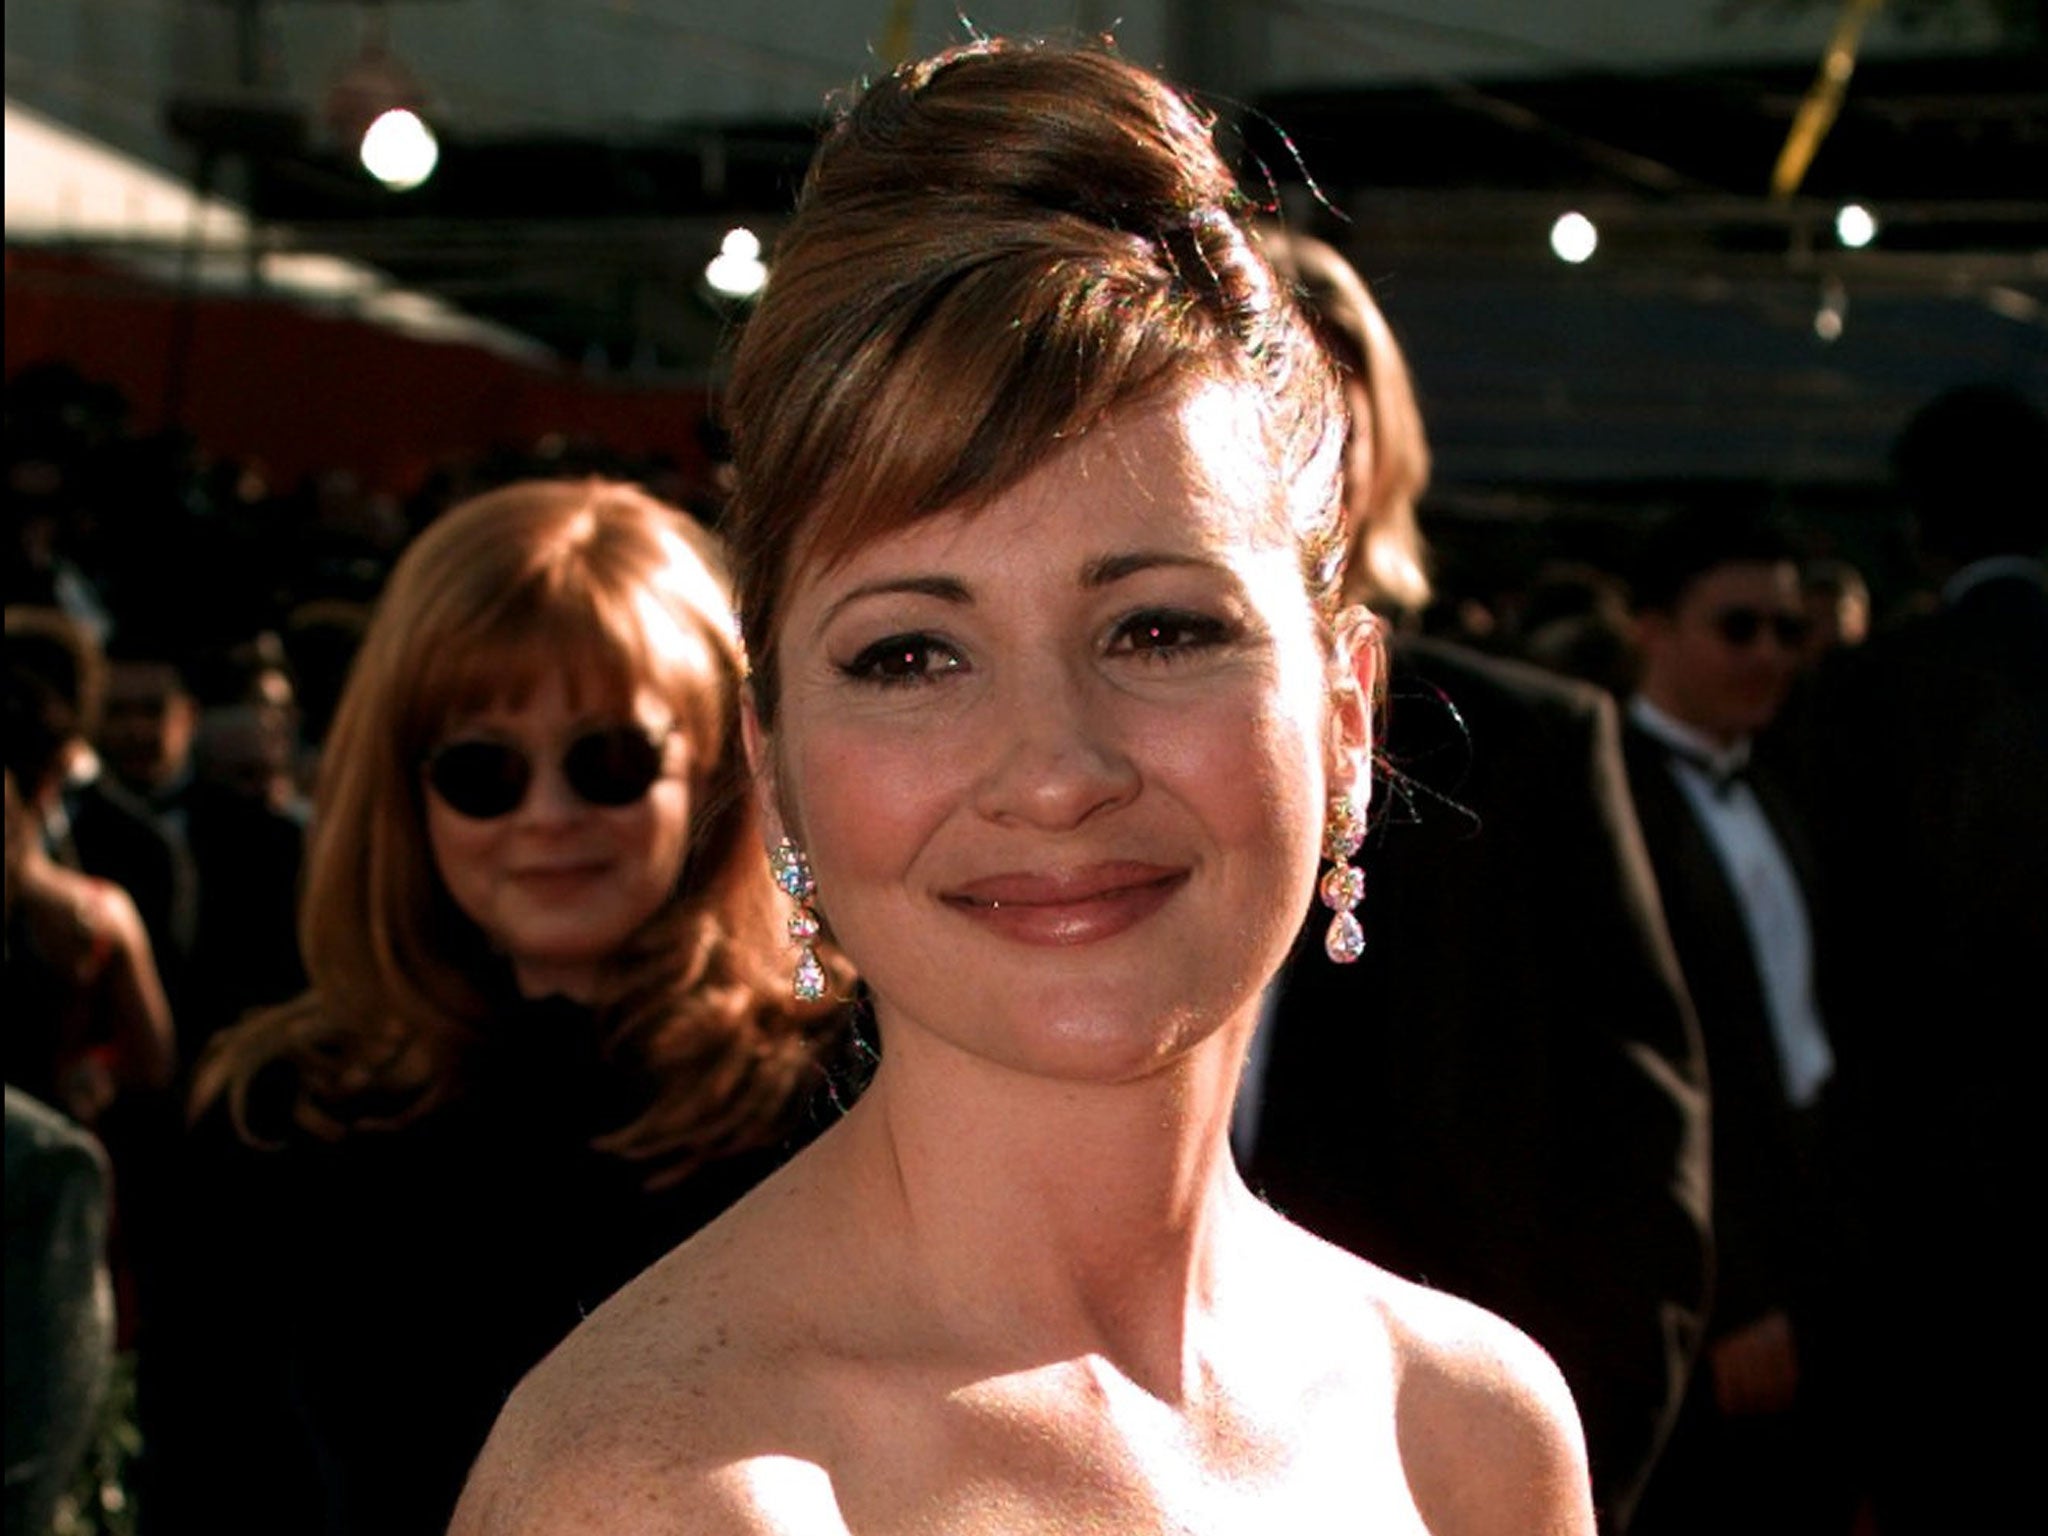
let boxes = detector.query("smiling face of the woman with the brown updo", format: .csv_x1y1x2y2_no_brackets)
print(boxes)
758,387,1370,1079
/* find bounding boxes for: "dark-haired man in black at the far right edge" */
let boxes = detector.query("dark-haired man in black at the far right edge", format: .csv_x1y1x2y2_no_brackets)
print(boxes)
1810,383,2048,1536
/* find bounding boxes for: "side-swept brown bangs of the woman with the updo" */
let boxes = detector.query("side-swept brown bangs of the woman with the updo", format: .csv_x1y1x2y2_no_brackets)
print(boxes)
739,219,1260,708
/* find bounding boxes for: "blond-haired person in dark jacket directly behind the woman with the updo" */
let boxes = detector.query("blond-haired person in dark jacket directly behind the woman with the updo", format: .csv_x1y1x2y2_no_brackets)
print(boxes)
1235,231,1708,1532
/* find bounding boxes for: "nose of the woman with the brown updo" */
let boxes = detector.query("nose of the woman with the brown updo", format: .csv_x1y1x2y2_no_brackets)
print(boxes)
977,666,1139,831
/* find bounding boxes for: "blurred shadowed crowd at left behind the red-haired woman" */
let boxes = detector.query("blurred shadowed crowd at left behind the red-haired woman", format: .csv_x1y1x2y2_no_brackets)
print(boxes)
4,365,745,1530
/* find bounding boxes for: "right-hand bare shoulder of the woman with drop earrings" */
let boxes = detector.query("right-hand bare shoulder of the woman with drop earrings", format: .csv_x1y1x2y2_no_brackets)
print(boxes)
1382,1278,1593,1536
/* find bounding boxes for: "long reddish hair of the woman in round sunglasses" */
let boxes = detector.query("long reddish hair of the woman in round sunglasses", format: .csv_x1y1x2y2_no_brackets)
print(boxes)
195,479,829,1182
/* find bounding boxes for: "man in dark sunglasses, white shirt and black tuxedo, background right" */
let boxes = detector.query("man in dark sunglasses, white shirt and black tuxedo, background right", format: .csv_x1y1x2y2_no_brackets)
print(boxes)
1624,506,1853,1536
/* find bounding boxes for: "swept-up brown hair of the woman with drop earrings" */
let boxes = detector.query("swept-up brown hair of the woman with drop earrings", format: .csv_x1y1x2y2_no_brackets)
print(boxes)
725,39,1346,725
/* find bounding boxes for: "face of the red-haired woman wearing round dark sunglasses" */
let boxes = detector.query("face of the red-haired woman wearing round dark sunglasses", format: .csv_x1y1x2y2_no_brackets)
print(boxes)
426,672,692,1001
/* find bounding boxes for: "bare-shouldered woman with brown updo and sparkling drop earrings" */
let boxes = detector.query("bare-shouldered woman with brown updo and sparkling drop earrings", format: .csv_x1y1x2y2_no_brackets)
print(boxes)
455,41,1591,1536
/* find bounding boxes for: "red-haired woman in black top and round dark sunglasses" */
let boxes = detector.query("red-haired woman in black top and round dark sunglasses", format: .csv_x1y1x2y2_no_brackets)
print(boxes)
145,481,844,1534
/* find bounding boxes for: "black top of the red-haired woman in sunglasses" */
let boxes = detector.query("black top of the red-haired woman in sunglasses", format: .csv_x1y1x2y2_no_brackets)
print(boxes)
141,999,836,1536
